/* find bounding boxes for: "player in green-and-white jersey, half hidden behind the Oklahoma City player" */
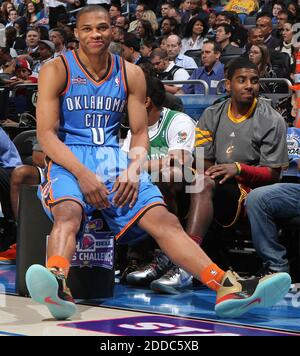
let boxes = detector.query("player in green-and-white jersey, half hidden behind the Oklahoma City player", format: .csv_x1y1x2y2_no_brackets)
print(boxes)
123,77,196,293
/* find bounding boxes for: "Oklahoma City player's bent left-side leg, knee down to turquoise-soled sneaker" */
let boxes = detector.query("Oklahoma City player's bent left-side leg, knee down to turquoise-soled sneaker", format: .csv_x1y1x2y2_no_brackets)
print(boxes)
26,201,82,320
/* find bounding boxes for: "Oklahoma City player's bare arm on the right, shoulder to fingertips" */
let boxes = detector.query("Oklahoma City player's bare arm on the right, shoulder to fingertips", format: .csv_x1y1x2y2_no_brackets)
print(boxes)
113,62,149,207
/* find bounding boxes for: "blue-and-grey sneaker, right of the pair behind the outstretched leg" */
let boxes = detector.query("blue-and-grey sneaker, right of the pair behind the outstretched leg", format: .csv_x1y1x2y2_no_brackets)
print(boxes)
150,266,193,294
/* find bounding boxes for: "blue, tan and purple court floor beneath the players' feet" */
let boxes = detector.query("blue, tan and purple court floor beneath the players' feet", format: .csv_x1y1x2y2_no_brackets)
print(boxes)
0,265,300,336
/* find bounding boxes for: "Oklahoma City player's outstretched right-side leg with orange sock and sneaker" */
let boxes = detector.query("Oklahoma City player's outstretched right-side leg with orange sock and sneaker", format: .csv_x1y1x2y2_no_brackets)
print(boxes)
139,206,291,318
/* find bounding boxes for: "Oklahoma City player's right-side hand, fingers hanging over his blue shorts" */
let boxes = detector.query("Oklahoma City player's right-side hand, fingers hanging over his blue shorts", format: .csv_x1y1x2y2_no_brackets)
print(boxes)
111,165,139,209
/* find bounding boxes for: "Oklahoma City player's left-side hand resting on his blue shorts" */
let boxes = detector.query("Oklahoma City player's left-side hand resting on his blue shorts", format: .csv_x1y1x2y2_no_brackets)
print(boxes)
77,169,110,209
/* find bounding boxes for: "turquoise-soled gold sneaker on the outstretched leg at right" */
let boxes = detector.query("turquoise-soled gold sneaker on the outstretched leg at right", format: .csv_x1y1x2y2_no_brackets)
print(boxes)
215,271,291,318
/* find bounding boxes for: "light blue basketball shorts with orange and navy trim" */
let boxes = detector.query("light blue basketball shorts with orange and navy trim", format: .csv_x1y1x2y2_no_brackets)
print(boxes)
38,145,165,244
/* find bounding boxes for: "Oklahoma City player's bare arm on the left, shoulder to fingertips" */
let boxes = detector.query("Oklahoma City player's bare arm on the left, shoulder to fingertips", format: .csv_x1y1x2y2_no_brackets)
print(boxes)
37,58,109,208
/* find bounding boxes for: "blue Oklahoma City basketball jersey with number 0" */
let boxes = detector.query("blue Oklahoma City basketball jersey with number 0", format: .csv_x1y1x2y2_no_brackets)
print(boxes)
58,51,127,147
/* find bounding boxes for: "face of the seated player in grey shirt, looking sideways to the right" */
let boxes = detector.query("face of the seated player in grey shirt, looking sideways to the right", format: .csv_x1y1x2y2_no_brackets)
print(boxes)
226,68,259,105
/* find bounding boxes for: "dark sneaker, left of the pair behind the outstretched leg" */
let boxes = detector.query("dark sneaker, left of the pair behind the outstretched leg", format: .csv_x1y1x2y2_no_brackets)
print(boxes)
126,250,172,286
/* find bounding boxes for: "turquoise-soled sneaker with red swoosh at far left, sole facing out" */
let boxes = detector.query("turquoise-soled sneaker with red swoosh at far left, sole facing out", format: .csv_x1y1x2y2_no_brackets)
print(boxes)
26,265,77,320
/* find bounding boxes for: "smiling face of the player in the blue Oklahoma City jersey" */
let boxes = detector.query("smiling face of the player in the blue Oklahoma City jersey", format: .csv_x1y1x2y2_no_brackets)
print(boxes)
75,11,112,54
